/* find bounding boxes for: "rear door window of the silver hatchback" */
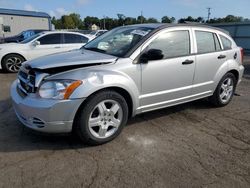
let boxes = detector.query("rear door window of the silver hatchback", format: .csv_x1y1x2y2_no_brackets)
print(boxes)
195,31,219,53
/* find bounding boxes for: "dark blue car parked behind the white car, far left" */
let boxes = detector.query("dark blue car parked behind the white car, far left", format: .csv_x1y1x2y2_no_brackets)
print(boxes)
3,29,46,43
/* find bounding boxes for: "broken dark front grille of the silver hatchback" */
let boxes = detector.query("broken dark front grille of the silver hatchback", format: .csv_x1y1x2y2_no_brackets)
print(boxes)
18,69,36,94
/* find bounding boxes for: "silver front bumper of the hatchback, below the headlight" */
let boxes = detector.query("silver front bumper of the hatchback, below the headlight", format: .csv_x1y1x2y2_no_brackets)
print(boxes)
11,81,84,133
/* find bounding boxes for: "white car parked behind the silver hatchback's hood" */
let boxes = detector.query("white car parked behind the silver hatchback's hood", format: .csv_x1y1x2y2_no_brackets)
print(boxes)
0,31,90,72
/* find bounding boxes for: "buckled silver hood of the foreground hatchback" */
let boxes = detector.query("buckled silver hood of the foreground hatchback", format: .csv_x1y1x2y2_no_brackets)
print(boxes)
25,49,117,69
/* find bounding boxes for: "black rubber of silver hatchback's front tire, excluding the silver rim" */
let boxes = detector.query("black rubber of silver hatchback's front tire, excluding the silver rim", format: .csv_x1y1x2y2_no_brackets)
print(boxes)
76,91,128,145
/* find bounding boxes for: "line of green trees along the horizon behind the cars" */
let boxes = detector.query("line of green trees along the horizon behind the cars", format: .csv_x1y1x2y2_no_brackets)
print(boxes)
51,13,250,30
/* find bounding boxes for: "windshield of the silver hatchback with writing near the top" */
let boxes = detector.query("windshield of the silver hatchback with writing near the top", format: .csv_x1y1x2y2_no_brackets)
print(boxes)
83,26,153,57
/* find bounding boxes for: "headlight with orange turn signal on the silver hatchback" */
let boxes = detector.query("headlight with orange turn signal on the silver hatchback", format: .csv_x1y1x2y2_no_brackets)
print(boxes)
39,80,82,99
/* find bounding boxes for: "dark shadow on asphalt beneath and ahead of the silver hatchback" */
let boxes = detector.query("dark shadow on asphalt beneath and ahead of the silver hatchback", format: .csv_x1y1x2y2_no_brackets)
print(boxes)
0,99,215,152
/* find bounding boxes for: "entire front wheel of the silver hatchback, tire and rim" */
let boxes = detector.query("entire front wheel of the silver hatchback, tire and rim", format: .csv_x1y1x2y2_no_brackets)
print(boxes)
74,90,128,145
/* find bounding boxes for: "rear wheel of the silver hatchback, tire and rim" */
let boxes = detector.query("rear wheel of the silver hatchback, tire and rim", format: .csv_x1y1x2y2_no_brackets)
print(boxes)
209,72,237,107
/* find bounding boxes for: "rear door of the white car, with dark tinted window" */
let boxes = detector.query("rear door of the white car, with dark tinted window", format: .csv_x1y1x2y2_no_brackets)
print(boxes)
62,33,88,51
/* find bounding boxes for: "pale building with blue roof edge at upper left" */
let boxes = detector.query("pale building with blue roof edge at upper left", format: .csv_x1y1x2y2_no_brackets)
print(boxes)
0,8,52,37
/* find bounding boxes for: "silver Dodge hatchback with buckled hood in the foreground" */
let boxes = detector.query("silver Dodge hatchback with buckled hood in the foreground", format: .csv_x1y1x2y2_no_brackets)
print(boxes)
11,24,244,145
